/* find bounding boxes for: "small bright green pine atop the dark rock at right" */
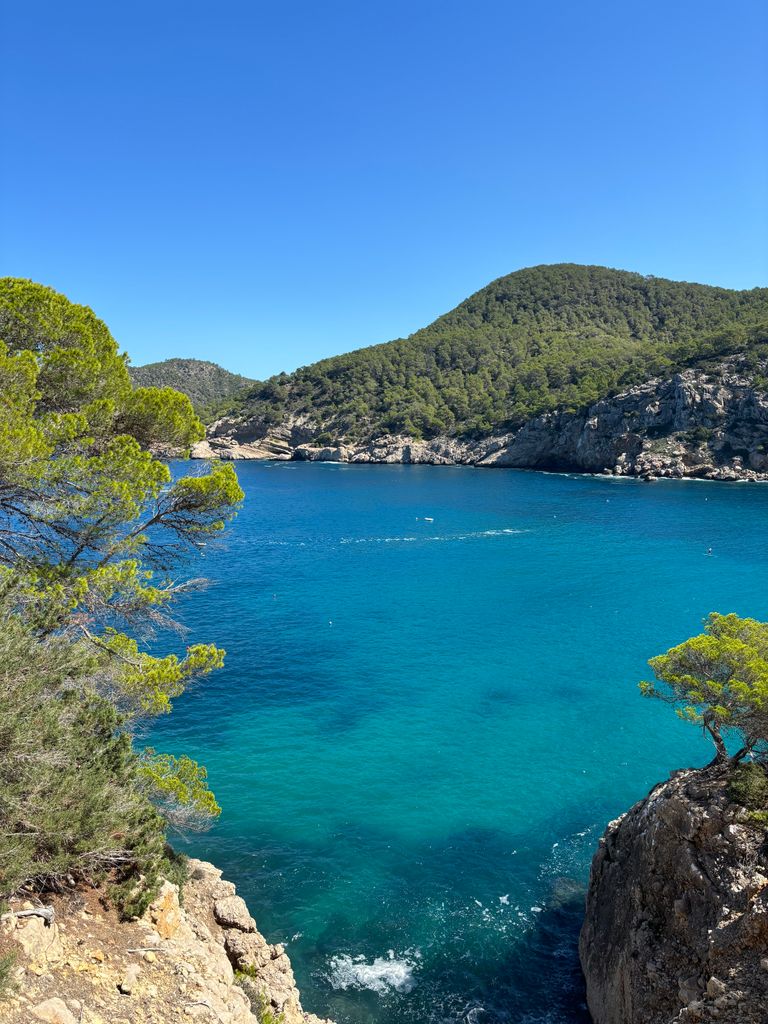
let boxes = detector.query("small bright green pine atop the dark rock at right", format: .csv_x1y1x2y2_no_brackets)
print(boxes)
640,612,768,764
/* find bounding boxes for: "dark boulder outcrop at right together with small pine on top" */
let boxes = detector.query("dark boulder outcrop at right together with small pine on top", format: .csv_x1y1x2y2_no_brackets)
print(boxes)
580,614,768,1024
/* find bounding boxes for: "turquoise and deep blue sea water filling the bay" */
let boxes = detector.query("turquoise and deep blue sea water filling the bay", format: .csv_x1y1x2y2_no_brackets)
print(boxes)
152,463,768,1024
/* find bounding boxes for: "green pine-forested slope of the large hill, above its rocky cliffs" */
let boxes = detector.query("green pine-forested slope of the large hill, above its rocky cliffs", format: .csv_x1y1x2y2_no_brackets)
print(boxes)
219,263,768,440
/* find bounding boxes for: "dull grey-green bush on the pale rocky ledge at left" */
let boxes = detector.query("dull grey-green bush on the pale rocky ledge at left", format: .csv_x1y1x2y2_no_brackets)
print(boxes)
0,594,165,898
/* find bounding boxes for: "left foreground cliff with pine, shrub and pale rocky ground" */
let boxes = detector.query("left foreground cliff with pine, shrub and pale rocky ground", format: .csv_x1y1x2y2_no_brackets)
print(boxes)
0,279,333,1024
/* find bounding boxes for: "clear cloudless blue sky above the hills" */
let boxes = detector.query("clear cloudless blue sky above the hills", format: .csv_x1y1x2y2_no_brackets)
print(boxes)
0,0,768,377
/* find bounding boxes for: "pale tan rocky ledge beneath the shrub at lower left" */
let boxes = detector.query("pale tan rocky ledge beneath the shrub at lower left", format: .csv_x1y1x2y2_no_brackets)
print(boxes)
0,860,332,1024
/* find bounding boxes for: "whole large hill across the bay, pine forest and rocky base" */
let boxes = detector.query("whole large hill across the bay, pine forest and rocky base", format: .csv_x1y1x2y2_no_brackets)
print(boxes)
185,263,768,478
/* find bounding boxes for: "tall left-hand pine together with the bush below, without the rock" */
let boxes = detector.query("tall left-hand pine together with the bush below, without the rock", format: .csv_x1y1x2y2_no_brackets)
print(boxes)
0,279,243,909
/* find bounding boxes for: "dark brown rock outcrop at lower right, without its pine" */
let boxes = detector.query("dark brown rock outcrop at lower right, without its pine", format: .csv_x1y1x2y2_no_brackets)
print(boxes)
580,770,768,1024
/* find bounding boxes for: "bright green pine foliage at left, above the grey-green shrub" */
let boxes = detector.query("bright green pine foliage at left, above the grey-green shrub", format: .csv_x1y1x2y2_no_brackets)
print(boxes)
0,279,243,713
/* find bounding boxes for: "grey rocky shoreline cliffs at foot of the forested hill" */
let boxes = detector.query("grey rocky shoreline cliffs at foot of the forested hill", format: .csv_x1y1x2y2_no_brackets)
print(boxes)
193,357,768,480
